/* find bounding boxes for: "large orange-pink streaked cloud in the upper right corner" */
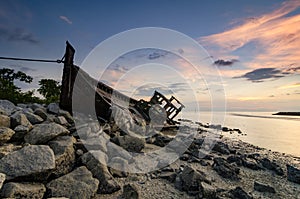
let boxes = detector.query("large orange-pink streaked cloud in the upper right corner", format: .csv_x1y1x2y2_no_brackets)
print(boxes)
199,0,300,72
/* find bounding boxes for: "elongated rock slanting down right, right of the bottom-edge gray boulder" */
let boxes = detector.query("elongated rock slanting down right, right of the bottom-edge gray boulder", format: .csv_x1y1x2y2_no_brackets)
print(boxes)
81,151,121,194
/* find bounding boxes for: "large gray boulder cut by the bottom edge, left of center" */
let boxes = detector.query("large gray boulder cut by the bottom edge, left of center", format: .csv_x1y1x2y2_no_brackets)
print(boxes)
46,166,99,199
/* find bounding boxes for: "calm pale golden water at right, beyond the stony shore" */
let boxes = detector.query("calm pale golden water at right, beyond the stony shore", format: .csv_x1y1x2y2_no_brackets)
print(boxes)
182,112,300,157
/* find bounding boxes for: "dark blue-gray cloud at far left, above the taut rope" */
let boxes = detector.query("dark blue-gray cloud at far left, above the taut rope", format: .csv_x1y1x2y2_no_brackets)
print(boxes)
0,27,39,44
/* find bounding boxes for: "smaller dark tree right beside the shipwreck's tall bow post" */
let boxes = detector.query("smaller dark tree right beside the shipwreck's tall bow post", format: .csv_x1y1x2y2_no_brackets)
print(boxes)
37,79,61,103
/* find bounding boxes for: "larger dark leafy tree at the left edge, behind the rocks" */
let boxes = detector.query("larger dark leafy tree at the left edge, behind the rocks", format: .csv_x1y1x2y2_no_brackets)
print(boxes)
0,68,39,104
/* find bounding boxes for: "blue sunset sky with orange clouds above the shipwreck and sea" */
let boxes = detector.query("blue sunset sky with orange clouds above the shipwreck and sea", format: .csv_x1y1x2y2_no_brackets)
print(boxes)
0,0,300,111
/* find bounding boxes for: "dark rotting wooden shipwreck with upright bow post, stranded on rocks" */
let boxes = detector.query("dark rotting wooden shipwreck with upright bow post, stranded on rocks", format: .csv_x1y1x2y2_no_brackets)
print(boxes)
60,42,184,126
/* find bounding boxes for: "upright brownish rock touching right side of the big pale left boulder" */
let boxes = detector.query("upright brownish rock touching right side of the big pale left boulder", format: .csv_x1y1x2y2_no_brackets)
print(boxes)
48,136,76,176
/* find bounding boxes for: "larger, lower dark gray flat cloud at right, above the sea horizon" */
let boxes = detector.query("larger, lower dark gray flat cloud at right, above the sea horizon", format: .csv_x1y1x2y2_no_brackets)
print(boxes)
235,68,288,82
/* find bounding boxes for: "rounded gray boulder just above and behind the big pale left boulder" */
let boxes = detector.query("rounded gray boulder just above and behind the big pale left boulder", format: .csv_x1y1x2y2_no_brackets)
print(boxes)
24,123,69,144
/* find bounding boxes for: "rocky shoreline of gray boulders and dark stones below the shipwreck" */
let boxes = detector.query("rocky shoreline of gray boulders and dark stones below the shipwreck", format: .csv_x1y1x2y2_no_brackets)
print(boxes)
0,100,300,199
